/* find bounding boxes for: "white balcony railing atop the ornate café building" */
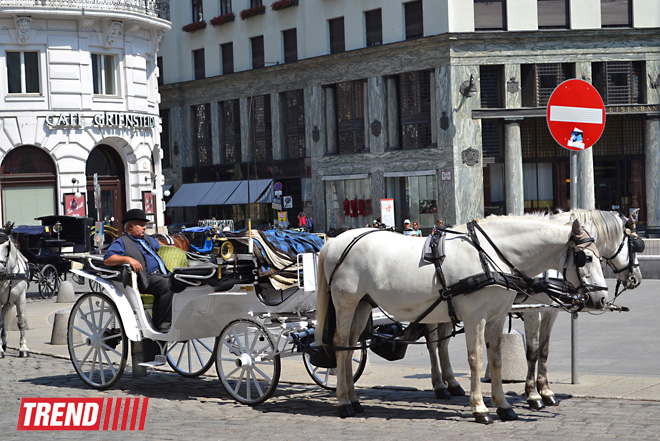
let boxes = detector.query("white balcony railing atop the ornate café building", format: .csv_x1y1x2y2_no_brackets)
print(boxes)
0,0,170,20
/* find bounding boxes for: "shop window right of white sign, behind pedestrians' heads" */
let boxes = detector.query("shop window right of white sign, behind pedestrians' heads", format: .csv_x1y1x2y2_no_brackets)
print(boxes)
385,173,442,229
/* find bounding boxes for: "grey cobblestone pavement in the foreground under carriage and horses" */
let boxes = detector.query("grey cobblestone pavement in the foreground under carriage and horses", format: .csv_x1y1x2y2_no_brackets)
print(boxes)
0,351,660,441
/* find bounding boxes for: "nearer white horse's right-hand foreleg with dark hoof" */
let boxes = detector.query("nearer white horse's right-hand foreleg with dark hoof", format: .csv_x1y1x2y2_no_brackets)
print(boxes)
485,315,518,421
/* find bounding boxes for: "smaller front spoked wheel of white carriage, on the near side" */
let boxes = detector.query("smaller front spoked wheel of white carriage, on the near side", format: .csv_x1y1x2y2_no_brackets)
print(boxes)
215,319,281,406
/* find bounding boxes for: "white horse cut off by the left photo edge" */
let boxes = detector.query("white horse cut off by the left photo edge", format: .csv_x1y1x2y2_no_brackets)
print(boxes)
0,224,30,358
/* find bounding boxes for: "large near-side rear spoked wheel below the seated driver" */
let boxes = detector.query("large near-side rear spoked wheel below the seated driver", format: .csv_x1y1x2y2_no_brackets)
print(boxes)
67,292,128,389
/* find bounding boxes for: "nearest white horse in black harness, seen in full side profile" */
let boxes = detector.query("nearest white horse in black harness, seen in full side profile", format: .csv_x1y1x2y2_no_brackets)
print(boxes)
316,217,607,423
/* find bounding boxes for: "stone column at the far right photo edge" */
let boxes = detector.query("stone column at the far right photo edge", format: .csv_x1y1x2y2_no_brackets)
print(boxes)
644,117,660,234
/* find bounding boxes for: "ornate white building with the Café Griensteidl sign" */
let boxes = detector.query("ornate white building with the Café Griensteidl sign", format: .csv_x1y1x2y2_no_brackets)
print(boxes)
0,0,170,228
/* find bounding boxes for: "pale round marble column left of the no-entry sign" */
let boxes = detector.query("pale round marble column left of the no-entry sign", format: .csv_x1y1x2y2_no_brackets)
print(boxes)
504,120,525,216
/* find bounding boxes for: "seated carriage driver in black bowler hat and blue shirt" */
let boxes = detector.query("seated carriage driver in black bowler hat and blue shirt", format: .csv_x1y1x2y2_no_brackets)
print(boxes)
103,208,174,332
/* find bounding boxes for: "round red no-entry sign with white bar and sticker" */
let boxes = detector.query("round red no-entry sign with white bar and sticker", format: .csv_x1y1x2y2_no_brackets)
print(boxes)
546,79,605,150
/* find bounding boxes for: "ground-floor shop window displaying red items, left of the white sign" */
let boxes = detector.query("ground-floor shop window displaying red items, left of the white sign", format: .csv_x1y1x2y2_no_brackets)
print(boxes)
325,176,373,231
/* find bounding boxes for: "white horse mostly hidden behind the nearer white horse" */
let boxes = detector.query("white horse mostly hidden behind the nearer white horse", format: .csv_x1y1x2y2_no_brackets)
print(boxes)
427,210,644,409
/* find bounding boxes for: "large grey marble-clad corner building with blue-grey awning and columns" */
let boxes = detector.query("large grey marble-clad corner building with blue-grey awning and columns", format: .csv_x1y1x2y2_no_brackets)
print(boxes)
158,0,660,231
